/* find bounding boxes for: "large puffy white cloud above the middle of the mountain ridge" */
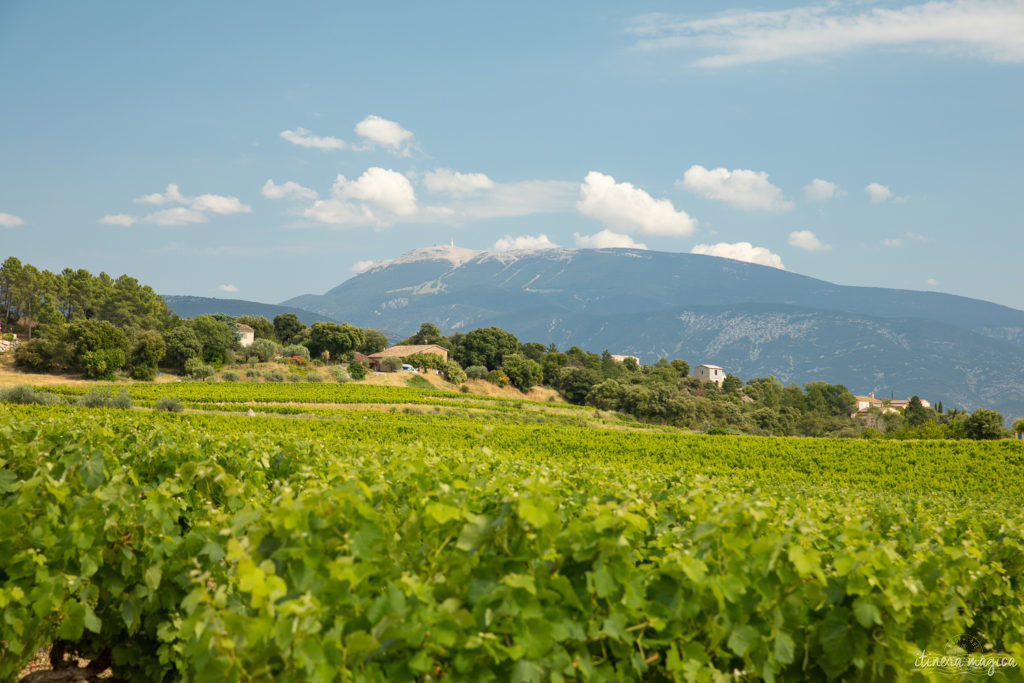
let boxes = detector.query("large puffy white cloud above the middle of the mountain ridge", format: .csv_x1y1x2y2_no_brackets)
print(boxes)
577,171,696,236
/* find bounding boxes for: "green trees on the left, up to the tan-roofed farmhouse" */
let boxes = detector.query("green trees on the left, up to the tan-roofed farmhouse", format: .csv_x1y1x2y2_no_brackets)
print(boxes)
0,257,395,380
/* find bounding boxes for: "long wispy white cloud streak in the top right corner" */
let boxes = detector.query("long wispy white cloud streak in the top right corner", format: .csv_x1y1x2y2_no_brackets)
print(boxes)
631,0,1024,68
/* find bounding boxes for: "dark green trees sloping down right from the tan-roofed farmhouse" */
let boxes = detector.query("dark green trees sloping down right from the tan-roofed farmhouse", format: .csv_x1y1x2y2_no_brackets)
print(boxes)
401,323,1011,438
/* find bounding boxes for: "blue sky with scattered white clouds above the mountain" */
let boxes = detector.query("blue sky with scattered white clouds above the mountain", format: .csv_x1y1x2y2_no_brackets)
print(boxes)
0,0,1024,313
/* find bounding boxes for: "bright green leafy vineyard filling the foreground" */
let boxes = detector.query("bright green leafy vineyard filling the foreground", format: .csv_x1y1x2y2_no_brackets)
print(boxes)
0,383,1024,681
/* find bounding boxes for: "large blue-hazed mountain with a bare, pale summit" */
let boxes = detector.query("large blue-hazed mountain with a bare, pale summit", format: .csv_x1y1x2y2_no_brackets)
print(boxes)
284,247,1024,417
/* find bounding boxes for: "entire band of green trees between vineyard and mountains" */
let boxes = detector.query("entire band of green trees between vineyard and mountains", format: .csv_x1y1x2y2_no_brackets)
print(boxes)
0,257,1007,438
